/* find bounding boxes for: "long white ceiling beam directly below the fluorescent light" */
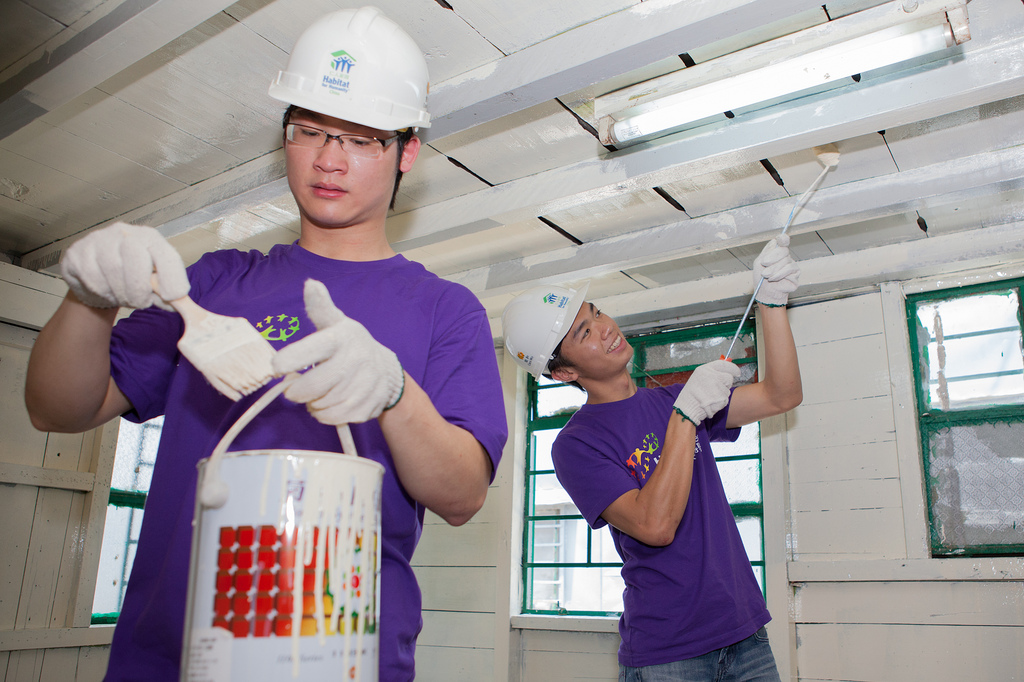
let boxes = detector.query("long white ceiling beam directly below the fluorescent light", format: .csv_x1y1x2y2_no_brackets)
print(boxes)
388,27,1024,251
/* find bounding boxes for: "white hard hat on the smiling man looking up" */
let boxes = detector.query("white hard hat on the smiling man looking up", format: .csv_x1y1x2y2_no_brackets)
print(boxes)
502,283,589,378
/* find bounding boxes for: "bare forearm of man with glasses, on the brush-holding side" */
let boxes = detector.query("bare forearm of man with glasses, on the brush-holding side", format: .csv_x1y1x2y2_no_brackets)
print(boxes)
25,292,131,433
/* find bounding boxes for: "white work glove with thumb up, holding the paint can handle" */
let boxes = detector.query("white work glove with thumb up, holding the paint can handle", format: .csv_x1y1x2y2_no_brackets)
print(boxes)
273,280,406,426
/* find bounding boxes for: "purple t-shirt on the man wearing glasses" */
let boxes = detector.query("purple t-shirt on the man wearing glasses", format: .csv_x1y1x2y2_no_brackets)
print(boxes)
105,245,508,682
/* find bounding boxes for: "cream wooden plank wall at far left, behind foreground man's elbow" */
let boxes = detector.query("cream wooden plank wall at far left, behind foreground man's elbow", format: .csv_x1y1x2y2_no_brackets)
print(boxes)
0,263,116,682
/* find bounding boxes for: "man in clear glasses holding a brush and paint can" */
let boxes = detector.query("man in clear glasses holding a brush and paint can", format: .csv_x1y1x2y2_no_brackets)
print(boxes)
26,7,507,682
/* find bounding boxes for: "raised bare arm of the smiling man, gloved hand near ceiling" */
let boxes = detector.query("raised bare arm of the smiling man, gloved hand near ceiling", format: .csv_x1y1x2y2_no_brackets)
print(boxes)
726,304,804,428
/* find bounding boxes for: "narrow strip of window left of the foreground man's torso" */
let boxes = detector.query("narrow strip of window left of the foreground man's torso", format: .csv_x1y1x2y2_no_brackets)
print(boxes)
92,417,164,625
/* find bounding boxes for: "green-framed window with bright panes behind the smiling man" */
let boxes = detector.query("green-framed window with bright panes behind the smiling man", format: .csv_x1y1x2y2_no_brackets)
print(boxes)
522,315,765,615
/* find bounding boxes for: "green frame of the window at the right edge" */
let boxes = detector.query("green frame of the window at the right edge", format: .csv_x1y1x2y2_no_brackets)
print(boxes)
904,278,1024,559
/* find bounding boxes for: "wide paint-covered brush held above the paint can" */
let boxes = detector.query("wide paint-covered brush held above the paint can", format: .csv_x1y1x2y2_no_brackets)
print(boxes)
152,274,274,400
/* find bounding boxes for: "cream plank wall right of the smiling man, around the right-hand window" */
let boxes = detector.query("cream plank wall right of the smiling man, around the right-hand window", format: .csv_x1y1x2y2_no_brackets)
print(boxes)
783,286,1024,682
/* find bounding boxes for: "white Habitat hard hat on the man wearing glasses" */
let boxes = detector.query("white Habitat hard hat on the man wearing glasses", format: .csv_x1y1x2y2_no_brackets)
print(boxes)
270,7,430,130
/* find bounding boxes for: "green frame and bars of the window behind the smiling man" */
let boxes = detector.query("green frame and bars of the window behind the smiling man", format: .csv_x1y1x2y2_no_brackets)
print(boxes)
519,317,767,617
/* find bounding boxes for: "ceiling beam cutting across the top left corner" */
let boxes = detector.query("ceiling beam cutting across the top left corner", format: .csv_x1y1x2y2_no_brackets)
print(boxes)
0,0,233,139
